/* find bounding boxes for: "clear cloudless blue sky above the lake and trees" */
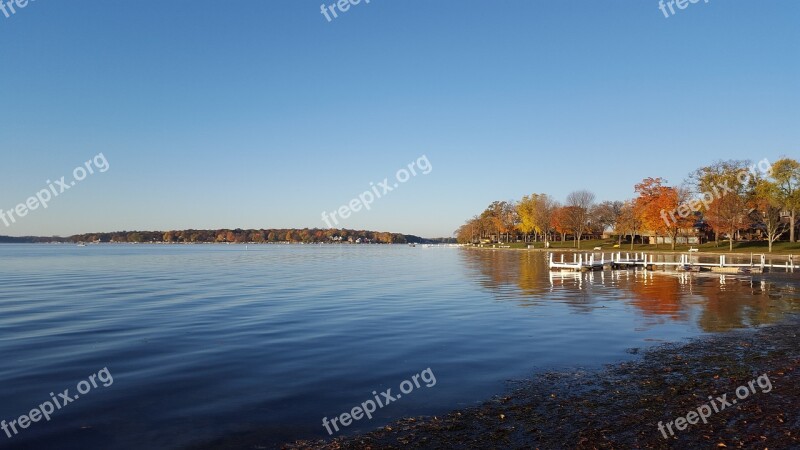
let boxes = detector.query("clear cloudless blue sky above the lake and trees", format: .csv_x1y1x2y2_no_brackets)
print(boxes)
0,0,800,237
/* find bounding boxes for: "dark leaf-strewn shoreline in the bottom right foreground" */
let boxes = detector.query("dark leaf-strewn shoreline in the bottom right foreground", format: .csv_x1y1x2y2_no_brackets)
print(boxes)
282,313,800,450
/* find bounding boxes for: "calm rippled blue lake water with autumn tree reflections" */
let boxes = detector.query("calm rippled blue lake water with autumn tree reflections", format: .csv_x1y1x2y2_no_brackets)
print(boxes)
0,245,800,449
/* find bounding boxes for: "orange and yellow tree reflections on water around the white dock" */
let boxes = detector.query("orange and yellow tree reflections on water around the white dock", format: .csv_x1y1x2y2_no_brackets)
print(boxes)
462,251,800,332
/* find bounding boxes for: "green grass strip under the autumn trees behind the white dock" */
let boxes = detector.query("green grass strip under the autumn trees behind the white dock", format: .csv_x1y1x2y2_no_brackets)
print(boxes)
476,239,800,255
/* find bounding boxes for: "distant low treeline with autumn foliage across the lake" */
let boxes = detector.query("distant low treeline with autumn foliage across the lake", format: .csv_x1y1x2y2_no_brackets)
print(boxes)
0,228,455,244
